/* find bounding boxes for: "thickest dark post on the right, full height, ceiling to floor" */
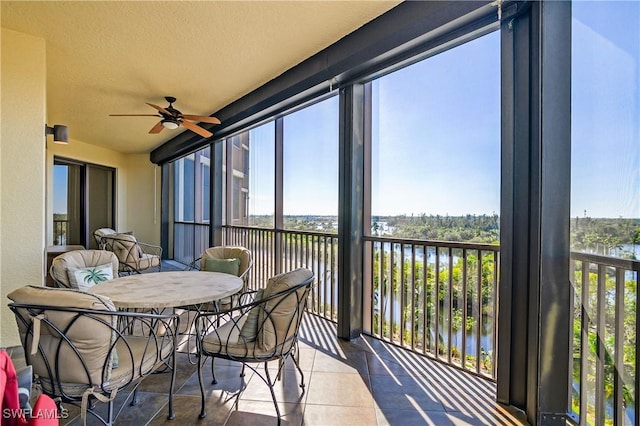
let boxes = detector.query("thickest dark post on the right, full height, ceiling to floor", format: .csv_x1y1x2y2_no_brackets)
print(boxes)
497,1,571,425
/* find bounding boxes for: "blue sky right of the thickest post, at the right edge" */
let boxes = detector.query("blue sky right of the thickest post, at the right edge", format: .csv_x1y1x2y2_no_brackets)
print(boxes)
571,1,640,218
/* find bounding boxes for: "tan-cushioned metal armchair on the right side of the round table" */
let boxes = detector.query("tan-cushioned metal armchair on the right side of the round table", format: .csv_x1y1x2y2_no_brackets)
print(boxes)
195,268,314,424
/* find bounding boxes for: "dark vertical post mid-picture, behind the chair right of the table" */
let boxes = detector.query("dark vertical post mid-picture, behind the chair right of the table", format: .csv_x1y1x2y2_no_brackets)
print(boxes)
338,84,365,339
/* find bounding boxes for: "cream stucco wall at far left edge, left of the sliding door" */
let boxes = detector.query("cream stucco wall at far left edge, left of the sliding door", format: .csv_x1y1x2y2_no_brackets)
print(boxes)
0,28,46,346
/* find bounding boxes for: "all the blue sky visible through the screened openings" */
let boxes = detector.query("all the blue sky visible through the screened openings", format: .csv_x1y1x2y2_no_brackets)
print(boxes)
54,1,640,218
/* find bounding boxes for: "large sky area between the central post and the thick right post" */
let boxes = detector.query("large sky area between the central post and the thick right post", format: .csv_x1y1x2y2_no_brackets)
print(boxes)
372,32,500,216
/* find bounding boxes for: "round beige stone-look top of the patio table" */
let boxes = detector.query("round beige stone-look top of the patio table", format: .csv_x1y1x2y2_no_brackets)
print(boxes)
89,271,243,309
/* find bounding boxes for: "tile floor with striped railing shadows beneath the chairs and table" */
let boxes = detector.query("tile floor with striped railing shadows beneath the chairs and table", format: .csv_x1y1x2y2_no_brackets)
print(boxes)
7,315,526,426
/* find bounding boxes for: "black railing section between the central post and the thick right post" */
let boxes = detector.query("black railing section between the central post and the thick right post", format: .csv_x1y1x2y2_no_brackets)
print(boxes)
365,237,500,379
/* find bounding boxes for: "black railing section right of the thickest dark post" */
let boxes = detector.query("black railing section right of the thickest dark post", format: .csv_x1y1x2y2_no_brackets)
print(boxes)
569,253,640,425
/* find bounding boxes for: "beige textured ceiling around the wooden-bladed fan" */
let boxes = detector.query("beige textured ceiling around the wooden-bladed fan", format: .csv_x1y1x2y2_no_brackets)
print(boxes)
0,0,399,153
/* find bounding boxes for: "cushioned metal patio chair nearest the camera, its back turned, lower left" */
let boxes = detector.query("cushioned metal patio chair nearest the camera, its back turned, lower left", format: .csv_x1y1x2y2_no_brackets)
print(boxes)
8,286,179,425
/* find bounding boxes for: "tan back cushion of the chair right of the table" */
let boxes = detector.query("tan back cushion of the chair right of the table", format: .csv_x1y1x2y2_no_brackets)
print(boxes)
258,268,313,350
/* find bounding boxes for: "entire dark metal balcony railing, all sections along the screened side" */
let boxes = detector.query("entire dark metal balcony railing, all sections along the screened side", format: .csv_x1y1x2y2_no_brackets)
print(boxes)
215,227,640,425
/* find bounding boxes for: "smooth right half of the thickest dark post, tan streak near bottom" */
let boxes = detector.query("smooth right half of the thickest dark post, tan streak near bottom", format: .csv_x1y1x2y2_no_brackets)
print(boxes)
534,1,572,425
